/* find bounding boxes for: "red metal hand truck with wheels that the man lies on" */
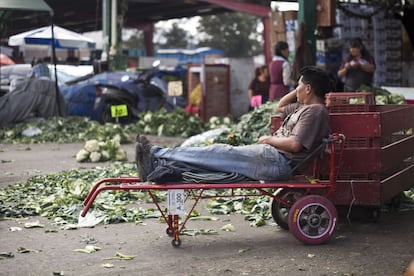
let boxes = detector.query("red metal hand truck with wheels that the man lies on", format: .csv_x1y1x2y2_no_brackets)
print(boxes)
81,134,344,247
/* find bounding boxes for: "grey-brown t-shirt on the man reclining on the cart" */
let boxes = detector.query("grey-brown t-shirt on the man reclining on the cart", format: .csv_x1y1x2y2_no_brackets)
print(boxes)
274,103,330,163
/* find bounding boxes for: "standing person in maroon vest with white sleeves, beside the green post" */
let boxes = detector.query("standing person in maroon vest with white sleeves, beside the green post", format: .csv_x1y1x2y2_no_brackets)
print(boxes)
269,41,295,101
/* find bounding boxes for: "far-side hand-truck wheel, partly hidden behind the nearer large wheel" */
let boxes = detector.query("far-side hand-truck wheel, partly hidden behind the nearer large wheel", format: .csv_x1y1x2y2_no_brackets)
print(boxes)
271,189,303,230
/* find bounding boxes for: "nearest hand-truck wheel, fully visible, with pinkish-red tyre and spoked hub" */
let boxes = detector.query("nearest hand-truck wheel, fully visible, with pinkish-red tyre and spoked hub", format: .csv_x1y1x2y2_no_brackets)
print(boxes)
288,195,338,244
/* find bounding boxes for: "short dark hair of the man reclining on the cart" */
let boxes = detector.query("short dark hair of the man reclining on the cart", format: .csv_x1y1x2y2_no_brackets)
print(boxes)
300,66,332,99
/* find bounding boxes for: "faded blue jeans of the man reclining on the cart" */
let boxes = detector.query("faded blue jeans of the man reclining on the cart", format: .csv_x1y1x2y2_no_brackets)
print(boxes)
151,144,291,181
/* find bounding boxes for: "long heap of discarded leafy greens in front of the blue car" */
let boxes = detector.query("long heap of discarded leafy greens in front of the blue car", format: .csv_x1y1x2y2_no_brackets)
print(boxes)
0,108,208,144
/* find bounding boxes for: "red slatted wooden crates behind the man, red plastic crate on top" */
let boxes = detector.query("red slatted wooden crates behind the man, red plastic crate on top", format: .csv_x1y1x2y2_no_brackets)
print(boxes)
325,92,414,206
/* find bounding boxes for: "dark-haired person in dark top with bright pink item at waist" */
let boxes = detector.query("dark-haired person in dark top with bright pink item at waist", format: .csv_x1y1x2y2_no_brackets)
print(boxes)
248,65,270,109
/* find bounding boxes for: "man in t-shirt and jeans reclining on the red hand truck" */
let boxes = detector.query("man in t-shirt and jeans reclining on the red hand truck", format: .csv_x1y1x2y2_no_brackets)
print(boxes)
136,66,331,183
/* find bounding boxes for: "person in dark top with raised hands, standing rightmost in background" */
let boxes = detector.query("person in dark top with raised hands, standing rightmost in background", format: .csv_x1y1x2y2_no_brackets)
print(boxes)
338,38,376,92
